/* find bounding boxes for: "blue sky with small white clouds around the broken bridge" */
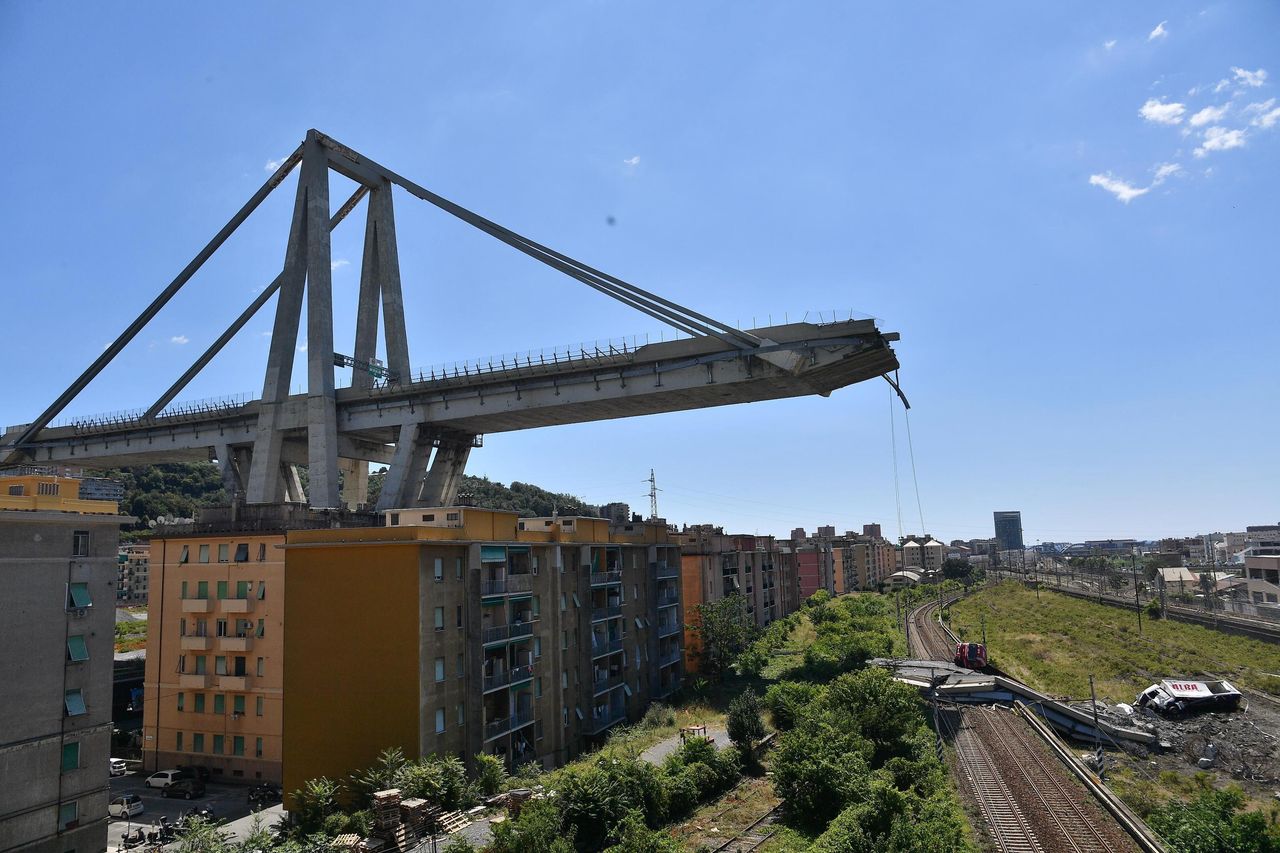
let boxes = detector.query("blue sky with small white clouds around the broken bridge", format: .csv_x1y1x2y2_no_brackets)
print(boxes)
0,3,1280,542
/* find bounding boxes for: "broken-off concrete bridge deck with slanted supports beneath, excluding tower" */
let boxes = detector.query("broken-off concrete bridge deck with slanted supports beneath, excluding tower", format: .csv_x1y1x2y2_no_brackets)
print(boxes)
0,320,897,508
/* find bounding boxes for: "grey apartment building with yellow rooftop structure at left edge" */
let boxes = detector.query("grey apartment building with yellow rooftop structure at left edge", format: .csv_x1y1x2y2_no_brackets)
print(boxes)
0,474,133,853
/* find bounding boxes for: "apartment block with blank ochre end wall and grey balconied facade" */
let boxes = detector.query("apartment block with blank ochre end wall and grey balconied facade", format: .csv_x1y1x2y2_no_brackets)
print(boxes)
283,507,684,790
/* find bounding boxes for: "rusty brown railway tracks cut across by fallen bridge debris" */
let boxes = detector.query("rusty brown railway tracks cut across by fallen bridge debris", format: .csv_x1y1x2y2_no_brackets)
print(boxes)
908,601,1138,853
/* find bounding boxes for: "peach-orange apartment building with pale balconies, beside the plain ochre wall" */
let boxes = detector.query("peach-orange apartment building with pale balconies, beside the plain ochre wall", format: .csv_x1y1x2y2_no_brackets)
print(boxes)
142,530,285,783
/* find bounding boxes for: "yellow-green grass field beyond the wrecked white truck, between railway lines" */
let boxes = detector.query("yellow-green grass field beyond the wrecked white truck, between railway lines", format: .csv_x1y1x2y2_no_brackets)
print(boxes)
950,581,1280,702
